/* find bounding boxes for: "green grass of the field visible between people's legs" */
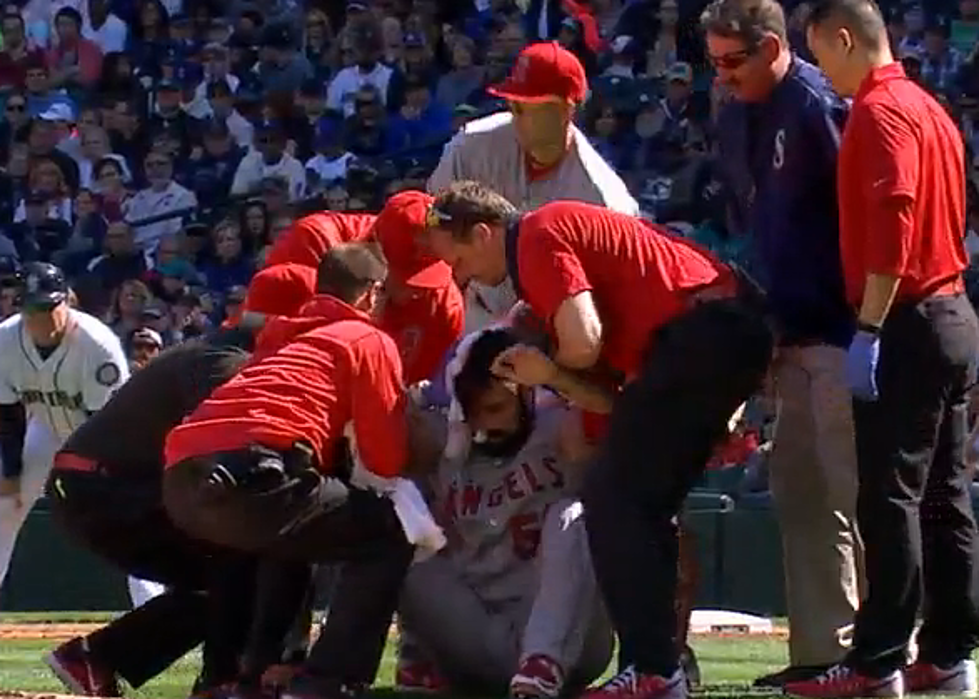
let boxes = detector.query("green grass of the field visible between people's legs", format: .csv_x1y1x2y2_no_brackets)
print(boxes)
0,615,972,699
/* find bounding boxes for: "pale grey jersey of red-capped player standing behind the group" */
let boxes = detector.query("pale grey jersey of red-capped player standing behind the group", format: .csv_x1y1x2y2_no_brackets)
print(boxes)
428,112,639,333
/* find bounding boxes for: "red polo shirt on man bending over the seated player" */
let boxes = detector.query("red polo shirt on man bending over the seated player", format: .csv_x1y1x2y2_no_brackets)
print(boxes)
508,201,730,378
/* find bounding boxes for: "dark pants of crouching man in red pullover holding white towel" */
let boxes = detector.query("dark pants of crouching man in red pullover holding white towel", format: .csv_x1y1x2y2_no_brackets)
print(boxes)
164,448,413,685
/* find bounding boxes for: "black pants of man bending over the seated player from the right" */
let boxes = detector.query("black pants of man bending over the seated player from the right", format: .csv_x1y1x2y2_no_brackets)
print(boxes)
584,299,773,676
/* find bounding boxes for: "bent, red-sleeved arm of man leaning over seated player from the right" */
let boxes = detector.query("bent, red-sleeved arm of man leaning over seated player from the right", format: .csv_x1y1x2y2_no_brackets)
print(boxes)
513,229,613,413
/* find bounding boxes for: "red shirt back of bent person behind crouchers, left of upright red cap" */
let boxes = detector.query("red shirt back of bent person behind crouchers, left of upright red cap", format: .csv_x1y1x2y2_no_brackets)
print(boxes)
265,211,377,268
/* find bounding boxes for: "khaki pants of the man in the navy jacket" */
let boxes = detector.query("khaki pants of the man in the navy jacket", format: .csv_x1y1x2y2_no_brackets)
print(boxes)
769,345,863,665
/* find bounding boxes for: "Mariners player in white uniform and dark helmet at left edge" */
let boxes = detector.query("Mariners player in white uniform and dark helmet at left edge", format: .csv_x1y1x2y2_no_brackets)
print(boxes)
0,262,129,596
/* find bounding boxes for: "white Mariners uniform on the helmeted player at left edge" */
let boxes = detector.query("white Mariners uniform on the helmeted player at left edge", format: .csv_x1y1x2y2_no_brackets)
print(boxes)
0,309,129,600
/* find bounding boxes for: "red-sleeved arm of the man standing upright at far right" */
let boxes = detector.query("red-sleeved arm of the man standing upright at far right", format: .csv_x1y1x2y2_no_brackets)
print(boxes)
851,105,919,328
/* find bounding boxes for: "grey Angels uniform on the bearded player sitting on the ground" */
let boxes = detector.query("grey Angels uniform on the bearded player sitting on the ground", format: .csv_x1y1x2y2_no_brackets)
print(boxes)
400,400,613,692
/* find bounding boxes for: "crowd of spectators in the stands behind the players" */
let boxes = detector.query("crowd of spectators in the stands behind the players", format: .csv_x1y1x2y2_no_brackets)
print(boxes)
0,0,979,388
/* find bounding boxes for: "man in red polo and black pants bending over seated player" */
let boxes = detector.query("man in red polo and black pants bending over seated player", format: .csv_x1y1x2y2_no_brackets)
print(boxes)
426,182,772,699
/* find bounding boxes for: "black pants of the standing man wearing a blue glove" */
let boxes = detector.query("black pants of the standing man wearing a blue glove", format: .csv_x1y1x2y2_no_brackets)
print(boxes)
848,295,979,676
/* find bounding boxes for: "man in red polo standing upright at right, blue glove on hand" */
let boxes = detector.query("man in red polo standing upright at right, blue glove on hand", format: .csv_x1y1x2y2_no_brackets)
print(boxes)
786,0,979,697
